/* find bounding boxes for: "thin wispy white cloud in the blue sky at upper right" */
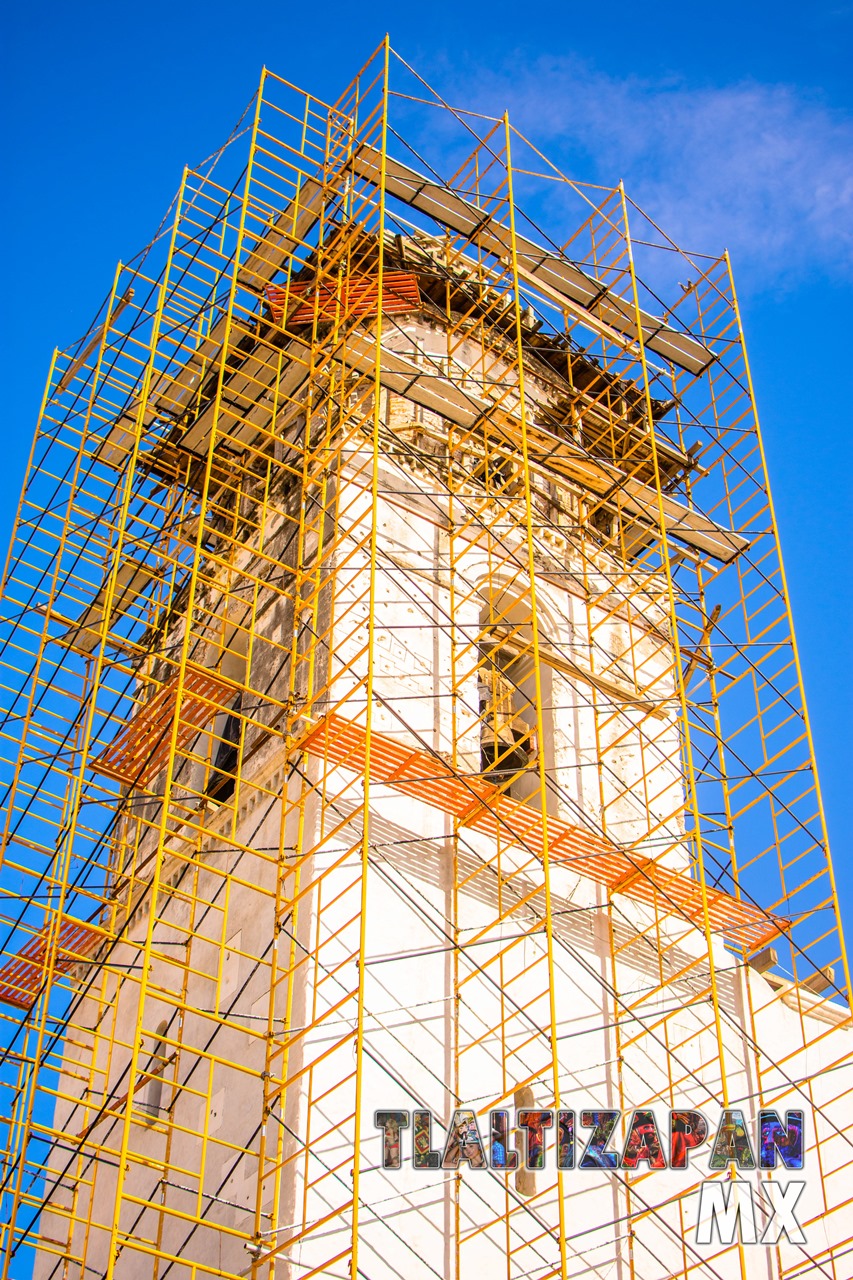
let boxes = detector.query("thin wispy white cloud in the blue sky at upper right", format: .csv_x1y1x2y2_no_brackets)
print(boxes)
432,58,853,287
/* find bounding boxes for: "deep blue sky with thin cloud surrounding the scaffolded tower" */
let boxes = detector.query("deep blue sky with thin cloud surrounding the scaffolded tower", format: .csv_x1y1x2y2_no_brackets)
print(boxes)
0,0,853,938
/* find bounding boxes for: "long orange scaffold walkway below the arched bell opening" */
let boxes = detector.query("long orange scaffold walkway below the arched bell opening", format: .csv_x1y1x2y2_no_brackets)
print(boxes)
298,714,790,950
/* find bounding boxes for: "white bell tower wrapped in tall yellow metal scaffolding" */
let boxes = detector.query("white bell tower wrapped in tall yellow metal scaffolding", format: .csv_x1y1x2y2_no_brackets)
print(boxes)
0,42,853,1280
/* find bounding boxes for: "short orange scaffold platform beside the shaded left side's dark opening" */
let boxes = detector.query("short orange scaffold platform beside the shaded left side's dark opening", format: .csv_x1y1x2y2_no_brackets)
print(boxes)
91,667,236,787
